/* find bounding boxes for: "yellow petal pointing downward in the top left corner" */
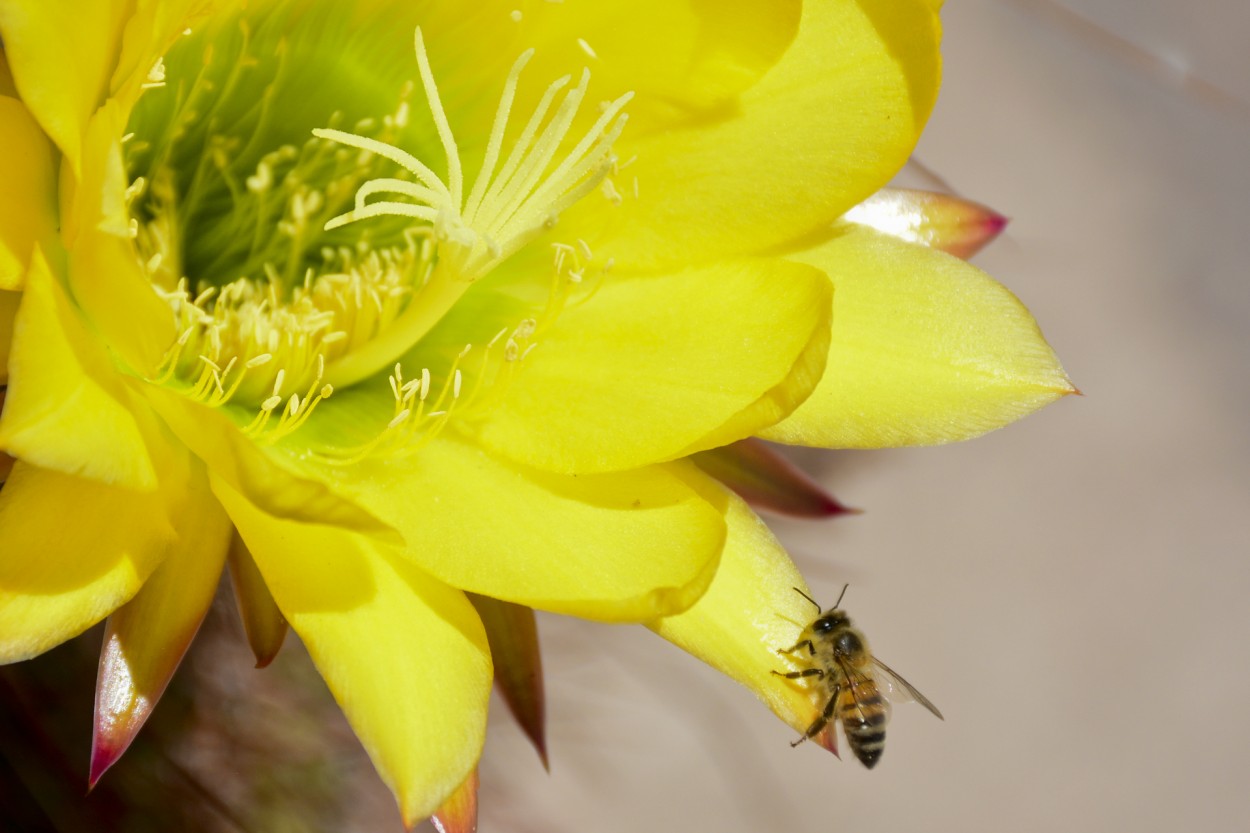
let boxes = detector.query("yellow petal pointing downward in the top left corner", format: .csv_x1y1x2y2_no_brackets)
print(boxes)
0,0,130,173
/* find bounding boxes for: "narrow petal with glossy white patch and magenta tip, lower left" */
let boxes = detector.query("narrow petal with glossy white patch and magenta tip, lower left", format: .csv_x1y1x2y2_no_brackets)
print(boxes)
88,467,230,787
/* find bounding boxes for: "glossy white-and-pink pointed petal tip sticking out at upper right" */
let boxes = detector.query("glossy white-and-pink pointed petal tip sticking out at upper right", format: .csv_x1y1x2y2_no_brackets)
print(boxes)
843,188,1008,260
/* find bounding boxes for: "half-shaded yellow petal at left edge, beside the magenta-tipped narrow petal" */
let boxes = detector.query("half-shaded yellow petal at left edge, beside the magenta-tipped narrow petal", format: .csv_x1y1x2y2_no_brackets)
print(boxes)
0,463,178,663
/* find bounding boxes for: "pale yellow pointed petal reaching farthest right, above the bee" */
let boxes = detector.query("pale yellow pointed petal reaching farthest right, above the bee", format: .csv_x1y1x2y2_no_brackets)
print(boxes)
761,226,1075,448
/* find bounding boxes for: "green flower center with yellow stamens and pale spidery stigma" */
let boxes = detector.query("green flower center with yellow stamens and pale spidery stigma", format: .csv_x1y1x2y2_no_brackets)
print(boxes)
124,4,630,440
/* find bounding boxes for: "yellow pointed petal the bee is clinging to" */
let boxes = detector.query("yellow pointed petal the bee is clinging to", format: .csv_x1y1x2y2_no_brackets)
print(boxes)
649,477,829,748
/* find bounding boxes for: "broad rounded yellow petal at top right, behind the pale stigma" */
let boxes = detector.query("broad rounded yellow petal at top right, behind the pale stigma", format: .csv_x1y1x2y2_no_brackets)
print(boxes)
580,0,940,269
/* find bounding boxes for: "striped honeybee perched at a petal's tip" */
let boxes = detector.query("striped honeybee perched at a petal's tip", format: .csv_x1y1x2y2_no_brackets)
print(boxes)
773,585,945,769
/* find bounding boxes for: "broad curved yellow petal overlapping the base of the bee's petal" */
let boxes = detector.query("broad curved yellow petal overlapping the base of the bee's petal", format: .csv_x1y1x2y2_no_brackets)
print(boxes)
351,437,724,622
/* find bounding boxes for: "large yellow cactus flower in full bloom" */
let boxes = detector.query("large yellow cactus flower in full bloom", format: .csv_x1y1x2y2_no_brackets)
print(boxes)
0,0,1073,822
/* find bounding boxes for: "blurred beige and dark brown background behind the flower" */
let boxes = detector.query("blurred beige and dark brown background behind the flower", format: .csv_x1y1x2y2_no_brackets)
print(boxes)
0,0,1250,833
